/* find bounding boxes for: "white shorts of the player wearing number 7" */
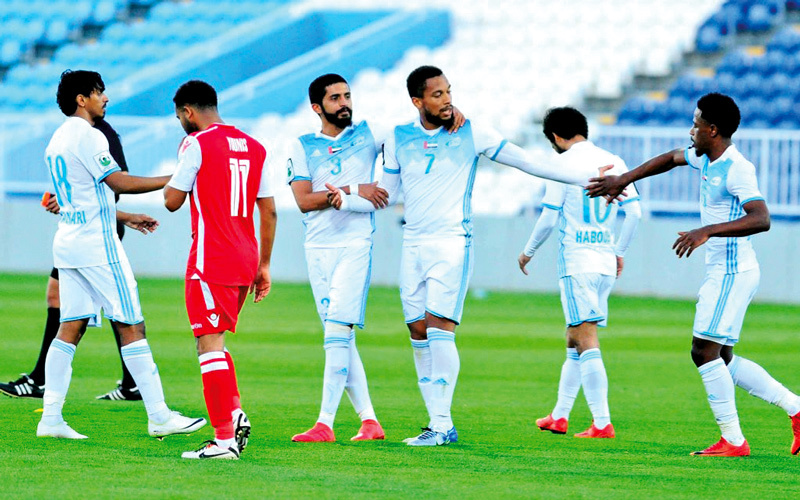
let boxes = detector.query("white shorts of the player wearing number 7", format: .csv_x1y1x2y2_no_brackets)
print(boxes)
400,237,473,324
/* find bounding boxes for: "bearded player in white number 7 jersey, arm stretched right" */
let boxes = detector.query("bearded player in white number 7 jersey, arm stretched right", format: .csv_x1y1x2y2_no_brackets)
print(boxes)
326,66,597,446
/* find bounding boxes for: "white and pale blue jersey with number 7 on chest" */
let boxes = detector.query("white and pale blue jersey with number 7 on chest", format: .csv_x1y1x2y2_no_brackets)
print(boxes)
383,119,506,243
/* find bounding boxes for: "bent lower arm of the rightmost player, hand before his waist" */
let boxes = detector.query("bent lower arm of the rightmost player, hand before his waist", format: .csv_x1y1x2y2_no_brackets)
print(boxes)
672,200,770,258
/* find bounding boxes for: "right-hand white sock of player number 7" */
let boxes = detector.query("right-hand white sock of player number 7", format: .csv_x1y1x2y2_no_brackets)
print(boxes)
427,328,461,433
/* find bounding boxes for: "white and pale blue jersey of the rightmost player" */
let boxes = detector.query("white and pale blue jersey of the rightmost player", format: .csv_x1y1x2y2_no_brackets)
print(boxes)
685,144,764,274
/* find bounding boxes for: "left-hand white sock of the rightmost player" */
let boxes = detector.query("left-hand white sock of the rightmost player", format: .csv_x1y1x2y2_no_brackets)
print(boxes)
697,358,744,446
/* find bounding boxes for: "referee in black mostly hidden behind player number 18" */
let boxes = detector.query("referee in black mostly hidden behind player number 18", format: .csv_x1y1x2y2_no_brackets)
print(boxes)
0,118,152,401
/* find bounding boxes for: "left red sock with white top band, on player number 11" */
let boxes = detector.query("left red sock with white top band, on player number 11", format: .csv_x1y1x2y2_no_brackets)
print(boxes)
200,351,234,439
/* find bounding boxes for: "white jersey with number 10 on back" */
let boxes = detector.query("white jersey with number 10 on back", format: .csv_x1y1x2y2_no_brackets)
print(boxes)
542,141,639,277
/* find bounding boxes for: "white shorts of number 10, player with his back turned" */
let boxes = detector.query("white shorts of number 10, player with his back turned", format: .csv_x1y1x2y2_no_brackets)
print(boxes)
558,273,616,326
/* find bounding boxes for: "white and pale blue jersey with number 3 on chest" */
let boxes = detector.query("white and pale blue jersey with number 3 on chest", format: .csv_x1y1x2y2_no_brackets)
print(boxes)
287,121,384,248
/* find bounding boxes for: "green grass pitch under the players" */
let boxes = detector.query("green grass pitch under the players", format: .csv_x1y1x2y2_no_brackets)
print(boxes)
0,274,800,499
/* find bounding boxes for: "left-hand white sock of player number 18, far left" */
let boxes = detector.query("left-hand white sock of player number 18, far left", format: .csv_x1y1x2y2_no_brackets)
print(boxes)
42,339,76,425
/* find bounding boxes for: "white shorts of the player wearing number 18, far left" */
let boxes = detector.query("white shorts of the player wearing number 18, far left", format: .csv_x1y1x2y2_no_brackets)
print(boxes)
58,258,144,326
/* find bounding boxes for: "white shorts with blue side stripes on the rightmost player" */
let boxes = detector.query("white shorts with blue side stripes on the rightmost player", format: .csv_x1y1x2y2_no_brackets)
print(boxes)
694,268,761,345
